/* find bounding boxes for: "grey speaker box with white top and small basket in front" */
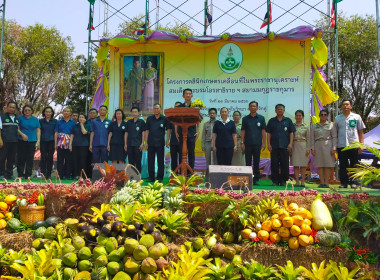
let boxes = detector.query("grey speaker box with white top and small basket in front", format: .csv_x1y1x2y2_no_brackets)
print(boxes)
208,165,253,190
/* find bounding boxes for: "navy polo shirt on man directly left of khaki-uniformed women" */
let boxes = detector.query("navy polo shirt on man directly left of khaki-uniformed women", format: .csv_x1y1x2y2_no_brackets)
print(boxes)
266,117,296,149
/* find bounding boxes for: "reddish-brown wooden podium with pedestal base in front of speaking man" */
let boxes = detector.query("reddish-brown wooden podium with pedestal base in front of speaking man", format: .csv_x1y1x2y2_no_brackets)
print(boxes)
165,107,203,177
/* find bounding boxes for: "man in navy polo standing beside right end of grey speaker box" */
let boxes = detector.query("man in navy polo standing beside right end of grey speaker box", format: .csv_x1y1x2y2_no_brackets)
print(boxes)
240,101,266,185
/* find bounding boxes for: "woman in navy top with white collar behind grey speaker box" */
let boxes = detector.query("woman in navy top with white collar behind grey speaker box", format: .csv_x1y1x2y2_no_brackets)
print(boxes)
212,107,237,165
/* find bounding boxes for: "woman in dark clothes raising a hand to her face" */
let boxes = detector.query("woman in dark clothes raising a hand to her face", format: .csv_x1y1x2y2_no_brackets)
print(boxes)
69,113,91,179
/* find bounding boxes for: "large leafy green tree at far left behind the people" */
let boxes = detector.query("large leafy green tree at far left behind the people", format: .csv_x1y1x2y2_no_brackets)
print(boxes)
0,21,75,115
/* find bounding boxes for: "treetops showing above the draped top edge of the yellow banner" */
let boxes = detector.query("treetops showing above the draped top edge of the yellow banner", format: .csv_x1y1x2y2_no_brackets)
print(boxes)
119,14,195,36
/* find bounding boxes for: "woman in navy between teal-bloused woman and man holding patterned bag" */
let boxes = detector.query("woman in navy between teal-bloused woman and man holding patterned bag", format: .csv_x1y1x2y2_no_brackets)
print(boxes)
40,106,57,179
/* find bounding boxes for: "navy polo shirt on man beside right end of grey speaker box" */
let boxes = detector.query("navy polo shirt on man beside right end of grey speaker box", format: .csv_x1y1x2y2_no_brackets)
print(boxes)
242,114,266,145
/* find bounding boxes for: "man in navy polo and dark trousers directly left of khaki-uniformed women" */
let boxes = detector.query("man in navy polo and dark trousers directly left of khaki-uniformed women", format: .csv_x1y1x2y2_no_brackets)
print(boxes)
266,104,296,186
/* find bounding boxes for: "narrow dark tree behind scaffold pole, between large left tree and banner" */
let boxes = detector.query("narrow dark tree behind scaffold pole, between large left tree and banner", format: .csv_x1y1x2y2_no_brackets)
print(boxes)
66,55,99,113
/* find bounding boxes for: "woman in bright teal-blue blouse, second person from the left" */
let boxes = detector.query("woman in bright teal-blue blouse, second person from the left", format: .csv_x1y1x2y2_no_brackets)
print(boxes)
17,105,41,179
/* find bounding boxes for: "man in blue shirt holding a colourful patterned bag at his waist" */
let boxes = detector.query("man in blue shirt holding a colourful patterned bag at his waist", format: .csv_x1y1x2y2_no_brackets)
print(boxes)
54,108,75,179
